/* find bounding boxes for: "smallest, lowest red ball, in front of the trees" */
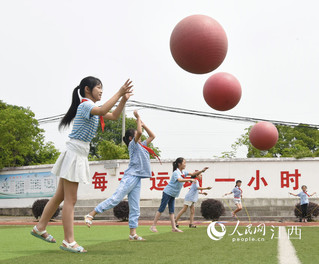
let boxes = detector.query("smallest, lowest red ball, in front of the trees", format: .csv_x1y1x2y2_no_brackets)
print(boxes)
249,121,278,150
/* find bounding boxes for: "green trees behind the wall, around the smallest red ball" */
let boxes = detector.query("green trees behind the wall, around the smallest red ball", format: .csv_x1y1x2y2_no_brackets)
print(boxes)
222,124,319,158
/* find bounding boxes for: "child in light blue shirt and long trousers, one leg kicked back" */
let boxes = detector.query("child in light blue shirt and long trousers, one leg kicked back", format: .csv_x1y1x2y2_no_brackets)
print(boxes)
84,111,155,240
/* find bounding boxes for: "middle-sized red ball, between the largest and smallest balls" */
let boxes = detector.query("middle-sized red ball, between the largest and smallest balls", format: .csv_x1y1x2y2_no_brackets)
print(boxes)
203,72,241,111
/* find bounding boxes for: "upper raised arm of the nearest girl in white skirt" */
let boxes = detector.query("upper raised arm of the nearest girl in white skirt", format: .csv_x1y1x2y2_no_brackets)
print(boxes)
91,79,133,116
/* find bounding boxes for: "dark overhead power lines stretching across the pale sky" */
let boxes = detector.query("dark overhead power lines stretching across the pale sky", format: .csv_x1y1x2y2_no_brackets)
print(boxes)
38,100,319,129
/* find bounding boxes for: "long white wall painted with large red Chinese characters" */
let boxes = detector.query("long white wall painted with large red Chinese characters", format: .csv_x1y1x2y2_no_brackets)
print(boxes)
0,158,319,208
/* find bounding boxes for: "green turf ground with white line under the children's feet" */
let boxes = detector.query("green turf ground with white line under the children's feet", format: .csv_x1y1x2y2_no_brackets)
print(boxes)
0,217,319,264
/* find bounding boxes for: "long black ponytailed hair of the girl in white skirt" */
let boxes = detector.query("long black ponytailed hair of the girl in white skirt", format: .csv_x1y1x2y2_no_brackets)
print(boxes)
59,76,102,129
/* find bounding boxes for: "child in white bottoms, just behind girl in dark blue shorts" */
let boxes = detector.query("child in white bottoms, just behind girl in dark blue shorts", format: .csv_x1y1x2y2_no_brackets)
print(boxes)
175,174,212,228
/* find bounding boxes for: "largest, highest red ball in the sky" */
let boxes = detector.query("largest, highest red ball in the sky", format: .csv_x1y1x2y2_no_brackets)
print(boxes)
170,15,228,74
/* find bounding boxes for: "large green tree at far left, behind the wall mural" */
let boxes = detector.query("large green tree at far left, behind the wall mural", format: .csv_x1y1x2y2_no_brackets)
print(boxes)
0,101,59,168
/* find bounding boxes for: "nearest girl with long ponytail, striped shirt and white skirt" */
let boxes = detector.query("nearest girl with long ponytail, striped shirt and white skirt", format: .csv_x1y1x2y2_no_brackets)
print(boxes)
31,76,133,253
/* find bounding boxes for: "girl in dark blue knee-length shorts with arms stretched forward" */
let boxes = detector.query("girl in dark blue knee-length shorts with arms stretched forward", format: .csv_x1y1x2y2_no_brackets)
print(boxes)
150,158,208,232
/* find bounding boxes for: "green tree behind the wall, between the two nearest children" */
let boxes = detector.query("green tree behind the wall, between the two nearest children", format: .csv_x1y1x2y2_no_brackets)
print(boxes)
89,115,160,160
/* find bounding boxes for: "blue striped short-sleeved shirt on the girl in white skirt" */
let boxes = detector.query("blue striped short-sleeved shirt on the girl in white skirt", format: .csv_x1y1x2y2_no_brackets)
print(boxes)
69,99,99,142
